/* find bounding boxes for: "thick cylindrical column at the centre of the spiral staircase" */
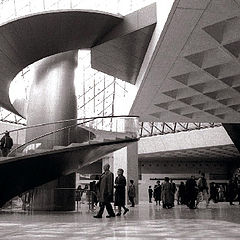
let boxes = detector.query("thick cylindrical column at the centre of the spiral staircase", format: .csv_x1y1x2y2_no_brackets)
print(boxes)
26,51,77,210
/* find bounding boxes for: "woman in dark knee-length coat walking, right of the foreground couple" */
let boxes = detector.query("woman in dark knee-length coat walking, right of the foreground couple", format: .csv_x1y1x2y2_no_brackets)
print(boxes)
114,168,129,216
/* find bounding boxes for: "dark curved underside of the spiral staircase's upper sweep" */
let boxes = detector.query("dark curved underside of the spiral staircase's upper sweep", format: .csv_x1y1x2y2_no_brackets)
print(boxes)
0,10,123,116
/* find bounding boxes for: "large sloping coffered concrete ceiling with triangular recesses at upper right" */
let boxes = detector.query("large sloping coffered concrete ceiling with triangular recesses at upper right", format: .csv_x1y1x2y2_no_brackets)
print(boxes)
130,0,240,123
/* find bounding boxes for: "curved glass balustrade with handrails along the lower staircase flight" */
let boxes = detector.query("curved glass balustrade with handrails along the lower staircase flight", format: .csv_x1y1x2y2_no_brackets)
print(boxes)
0,115,139,157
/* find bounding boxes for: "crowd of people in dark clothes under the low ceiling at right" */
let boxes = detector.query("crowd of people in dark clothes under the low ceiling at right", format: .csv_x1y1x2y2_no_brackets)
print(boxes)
148,173,240,209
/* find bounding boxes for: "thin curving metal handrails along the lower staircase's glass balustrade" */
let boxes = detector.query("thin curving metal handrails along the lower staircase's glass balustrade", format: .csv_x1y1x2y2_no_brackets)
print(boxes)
8,115,138,157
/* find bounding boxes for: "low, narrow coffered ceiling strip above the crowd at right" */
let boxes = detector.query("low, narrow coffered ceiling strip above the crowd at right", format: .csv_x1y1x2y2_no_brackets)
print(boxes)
139,144,240,161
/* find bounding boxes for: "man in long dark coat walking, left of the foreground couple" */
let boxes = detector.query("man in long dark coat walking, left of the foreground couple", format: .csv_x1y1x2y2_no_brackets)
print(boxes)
94,164,115,218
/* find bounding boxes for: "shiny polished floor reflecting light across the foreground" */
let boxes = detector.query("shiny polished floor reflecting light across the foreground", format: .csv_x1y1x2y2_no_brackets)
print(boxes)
0,203,240,240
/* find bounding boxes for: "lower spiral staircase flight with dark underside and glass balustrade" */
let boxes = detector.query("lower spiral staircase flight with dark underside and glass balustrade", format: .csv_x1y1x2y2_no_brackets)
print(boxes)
0,116,138,206
